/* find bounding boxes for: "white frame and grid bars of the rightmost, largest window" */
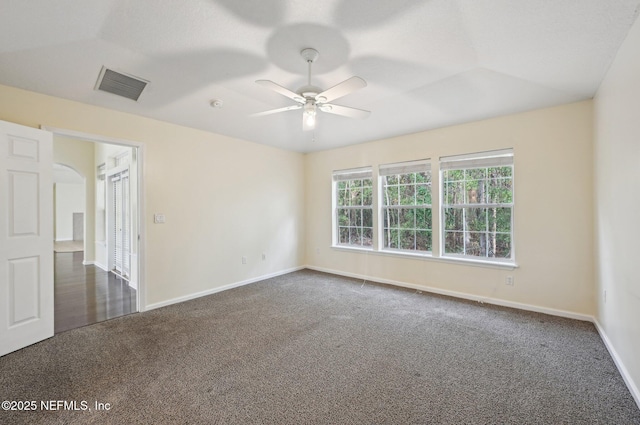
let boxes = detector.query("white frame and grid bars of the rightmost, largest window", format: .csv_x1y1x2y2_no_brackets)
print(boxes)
439,149,516,266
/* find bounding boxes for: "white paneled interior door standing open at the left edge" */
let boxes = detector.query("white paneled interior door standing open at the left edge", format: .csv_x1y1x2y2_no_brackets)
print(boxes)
0,121,53,356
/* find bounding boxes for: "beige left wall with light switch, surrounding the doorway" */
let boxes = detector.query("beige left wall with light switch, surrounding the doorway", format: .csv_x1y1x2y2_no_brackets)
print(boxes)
0,86,304,306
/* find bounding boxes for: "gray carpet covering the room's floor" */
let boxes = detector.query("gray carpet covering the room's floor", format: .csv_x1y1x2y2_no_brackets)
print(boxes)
0,270,640,424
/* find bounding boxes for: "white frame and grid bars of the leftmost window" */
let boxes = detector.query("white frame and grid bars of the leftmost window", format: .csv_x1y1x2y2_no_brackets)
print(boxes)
331,166,376,251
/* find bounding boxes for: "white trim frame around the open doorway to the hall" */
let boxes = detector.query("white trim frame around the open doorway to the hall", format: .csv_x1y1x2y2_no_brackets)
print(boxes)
40,125,147,312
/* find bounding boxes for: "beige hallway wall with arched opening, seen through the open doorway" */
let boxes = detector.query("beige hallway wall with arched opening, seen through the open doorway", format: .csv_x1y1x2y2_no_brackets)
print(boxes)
54,135,96,262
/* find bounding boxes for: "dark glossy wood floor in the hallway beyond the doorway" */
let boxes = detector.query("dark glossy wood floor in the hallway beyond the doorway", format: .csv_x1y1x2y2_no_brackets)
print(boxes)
54,251,137,333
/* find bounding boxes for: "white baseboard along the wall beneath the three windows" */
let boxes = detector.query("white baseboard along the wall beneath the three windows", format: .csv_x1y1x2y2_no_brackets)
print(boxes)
305,266,593,322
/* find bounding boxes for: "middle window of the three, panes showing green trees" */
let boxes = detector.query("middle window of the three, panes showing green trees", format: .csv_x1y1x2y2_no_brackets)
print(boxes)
379,160,432,252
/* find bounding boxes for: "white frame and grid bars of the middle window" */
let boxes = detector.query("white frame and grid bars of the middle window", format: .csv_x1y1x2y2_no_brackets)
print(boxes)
377,159,434,253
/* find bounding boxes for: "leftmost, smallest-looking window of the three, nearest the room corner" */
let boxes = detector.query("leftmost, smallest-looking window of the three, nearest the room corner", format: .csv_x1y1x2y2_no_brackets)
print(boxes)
333,168,373,248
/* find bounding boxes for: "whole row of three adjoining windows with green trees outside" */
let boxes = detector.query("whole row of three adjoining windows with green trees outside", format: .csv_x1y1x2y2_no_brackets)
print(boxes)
333,149,515,264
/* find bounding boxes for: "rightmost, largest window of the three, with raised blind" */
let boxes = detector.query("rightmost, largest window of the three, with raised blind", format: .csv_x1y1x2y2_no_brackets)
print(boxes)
440,149,514,262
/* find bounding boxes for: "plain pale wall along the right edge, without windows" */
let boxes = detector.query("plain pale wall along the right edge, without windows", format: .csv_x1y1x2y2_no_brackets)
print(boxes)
594,13,640,405
